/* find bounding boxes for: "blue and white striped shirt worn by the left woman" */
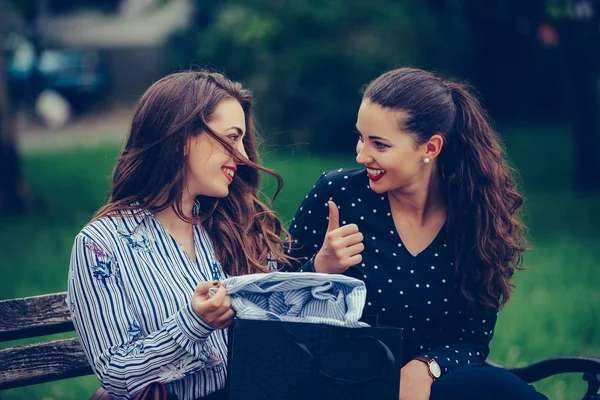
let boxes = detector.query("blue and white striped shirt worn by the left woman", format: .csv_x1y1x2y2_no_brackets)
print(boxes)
67,211,227,400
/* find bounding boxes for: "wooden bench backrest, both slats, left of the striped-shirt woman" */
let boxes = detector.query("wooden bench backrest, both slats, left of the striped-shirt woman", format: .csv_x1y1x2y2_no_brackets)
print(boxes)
0,293,93,390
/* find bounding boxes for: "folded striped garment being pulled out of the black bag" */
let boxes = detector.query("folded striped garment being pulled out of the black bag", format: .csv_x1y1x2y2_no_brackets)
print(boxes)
210,272,369,328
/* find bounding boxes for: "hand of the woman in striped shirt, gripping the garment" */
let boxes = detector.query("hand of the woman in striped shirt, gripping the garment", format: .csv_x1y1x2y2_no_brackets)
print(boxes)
192,281,235,329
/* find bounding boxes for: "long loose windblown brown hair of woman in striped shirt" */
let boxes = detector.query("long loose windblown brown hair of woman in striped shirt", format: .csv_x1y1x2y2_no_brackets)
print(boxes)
92,71,289,275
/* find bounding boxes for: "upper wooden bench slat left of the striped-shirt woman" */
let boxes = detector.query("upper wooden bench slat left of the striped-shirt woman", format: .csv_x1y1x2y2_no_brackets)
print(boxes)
0,292,74,342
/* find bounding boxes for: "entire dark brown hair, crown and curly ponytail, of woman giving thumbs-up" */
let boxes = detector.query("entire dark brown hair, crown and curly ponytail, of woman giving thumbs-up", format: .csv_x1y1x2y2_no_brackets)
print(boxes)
364,68,527,308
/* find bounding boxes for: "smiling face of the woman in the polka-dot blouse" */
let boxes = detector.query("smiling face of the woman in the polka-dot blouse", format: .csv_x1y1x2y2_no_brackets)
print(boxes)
356,99,427,193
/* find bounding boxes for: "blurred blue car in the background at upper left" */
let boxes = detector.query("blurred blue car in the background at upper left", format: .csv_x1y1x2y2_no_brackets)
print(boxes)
5,35,111,108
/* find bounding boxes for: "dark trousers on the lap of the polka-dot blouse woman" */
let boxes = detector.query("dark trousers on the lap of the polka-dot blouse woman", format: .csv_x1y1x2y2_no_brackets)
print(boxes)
429,366,548,400
